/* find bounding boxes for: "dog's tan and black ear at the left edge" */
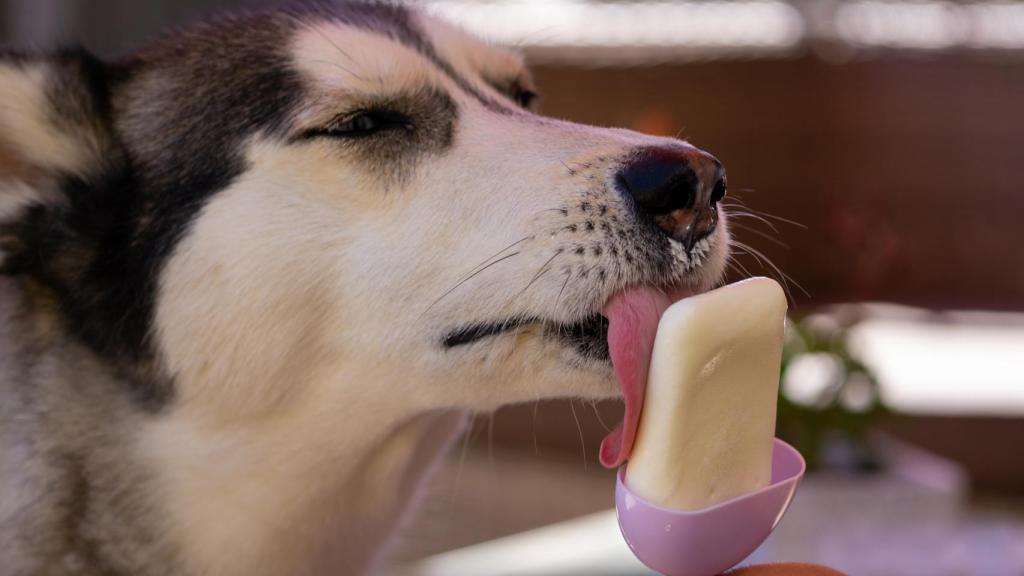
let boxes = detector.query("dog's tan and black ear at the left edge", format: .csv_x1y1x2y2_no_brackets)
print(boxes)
0,50,112,219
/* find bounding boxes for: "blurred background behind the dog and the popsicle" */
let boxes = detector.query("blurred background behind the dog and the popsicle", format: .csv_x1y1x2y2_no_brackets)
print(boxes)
0,0,1024,576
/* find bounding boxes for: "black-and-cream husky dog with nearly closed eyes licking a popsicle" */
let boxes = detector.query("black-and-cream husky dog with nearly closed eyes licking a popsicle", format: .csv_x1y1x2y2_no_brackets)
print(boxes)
0,4,729,576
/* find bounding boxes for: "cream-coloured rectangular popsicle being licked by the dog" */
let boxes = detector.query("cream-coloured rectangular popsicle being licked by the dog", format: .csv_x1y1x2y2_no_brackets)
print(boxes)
626,278,786,510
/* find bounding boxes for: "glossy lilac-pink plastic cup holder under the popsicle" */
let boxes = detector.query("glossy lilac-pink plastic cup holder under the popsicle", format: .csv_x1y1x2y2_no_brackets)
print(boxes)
615,438,807,576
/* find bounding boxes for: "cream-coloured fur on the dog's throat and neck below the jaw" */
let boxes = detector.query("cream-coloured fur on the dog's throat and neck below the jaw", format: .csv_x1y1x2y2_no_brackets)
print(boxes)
145,391,466,575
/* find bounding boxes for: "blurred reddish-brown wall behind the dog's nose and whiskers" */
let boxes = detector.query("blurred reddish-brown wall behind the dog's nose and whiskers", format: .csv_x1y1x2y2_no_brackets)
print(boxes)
536,55,1024,310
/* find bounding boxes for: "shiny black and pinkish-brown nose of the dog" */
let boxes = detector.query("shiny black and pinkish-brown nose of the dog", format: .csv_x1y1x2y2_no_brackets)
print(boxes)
616,148,726,251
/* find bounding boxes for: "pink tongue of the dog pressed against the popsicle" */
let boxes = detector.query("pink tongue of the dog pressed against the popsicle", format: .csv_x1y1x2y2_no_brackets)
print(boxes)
600,287,691,468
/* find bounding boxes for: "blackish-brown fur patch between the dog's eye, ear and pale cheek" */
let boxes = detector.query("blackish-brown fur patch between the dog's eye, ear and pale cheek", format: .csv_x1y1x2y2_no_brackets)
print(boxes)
4,13,302,409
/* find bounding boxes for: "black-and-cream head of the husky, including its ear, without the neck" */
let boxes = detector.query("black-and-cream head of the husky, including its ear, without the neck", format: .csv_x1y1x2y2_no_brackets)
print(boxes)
0,4,729,418
